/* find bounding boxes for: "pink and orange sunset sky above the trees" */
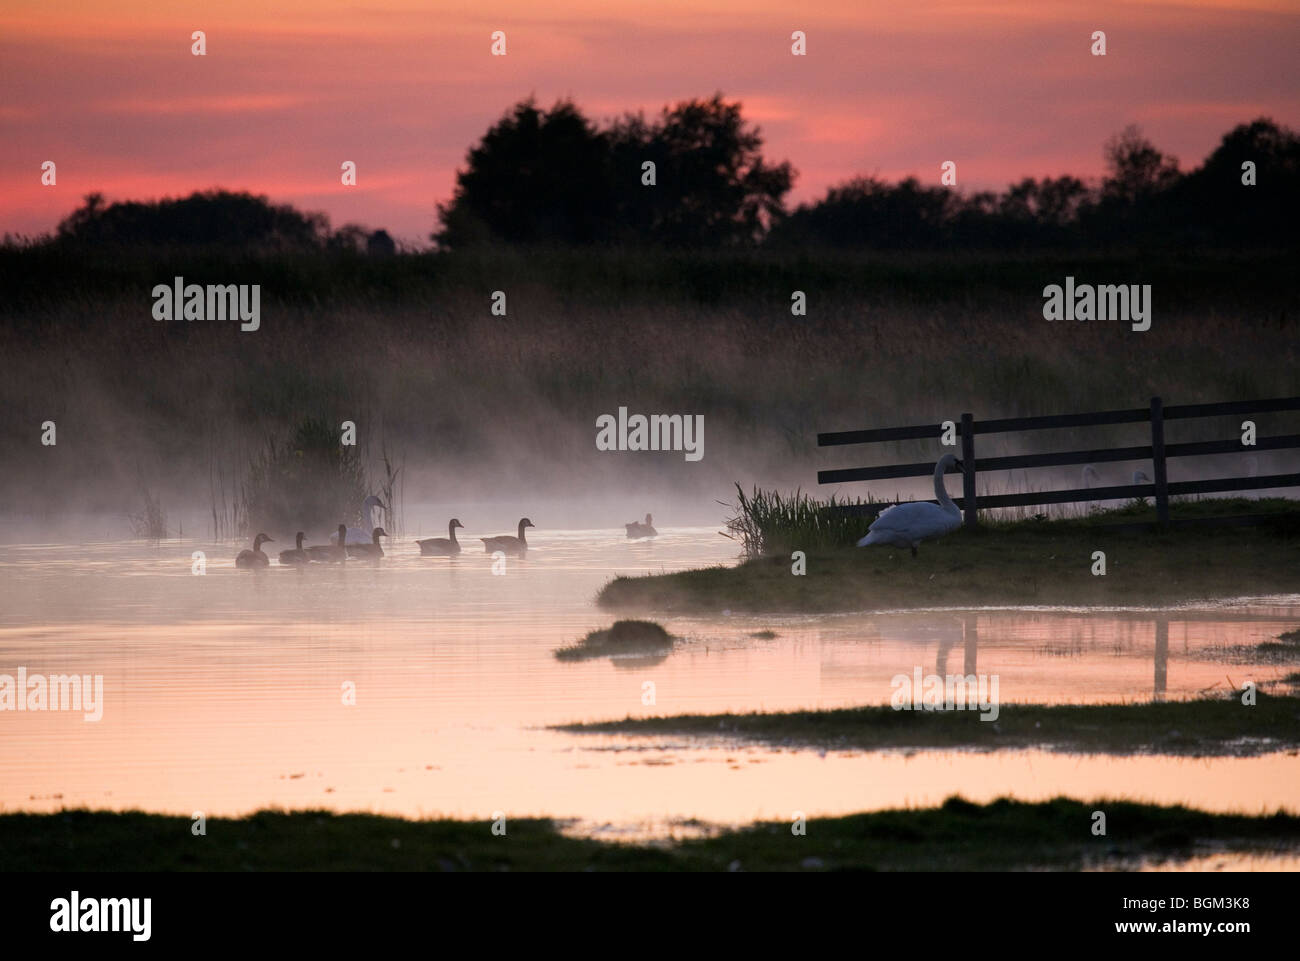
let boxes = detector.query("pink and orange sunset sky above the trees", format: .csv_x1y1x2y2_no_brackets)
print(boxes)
0,0,1300,243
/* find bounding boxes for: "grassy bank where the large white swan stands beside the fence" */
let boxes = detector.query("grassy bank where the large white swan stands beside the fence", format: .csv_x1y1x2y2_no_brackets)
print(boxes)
598,501,1300,612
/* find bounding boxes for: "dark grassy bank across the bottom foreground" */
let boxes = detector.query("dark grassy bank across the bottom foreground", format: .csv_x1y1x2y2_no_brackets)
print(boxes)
10,797,1300,871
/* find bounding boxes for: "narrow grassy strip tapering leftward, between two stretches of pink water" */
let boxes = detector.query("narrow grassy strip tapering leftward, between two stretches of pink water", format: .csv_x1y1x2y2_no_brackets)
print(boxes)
556,693,1300,757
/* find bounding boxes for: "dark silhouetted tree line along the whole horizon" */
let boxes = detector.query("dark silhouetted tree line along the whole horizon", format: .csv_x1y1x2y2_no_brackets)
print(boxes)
35,94,1300,254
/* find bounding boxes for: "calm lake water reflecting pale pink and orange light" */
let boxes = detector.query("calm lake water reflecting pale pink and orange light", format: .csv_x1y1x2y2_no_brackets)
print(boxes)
0,528,1300,847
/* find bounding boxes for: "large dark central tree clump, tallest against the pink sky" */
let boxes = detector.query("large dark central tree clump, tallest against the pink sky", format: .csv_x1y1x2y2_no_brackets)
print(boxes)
433,94,794,248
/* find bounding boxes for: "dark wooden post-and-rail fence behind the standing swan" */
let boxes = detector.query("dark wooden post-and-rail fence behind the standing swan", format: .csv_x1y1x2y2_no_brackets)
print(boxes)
816,397,1300,527
